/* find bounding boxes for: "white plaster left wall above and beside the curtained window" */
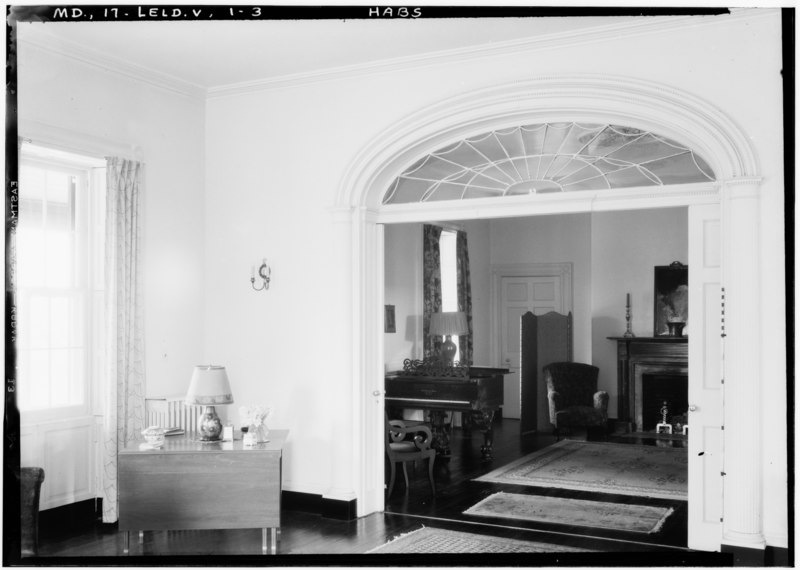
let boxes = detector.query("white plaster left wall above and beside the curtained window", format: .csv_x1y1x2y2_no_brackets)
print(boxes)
18,40,205,397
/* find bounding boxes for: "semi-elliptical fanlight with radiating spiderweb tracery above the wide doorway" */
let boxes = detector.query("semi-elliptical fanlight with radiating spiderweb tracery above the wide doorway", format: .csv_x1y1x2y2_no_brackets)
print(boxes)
383,123,715,204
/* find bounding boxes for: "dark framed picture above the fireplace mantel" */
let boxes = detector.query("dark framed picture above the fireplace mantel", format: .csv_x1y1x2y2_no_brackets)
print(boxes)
653,261,689,336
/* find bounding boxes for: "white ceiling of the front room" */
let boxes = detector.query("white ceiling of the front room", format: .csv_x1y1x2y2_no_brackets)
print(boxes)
18,14,652,89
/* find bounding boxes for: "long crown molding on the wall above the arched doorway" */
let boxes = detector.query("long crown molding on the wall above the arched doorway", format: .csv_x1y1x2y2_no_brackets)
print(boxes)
208,8,773,98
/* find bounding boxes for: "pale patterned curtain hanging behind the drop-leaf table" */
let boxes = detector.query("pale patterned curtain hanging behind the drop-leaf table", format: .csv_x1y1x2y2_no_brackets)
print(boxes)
102,158,145,523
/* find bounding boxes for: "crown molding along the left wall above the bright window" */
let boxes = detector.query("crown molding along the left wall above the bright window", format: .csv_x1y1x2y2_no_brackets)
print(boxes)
17,30,207,101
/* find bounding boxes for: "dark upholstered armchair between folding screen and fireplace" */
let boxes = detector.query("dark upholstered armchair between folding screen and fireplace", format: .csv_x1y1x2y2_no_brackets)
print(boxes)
542,362,608,436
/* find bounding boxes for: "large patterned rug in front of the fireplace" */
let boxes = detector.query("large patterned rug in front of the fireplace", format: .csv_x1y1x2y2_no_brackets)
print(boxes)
475,439,688,494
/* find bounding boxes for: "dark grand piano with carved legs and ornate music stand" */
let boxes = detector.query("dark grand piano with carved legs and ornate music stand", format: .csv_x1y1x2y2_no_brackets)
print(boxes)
385,359,509,460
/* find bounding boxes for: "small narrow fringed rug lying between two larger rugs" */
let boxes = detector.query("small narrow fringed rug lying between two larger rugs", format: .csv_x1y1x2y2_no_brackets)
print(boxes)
464,492,674,534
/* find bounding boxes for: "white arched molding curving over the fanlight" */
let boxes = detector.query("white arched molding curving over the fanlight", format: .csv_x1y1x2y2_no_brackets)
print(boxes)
337,74,758,212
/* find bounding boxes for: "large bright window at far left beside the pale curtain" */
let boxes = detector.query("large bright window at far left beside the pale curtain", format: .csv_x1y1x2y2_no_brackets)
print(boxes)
16,145,105,421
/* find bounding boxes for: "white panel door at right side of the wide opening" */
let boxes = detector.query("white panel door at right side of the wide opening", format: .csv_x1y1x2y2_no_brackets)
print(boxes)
688,205,723,550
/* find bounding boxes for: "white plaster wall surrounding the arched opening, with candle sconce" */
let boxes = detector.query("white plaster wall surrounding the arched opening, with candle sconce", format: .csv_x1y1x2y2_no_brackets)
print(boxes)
205,12,785,520
